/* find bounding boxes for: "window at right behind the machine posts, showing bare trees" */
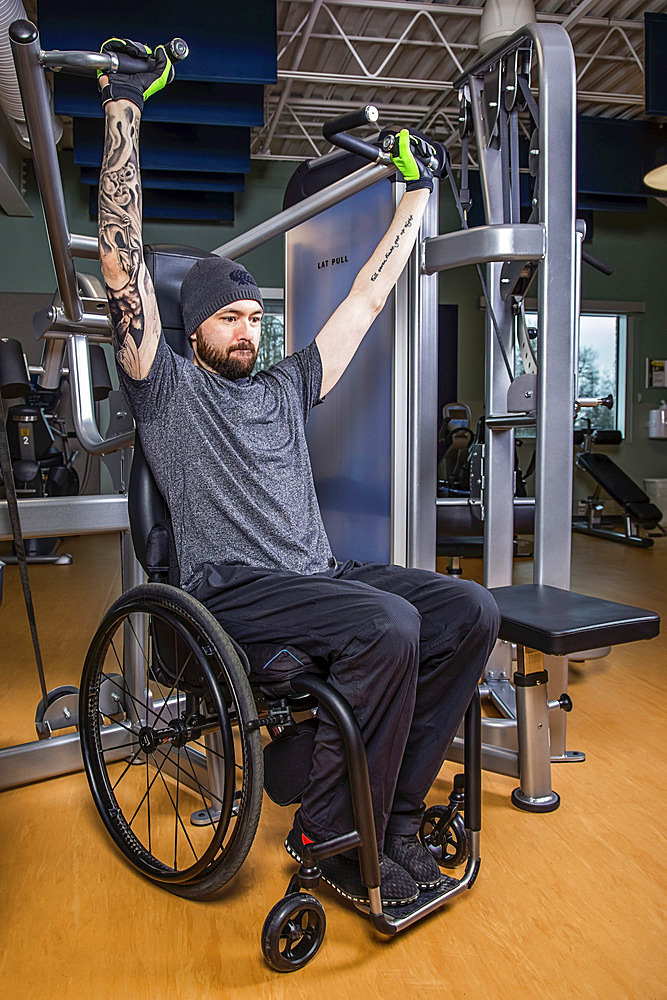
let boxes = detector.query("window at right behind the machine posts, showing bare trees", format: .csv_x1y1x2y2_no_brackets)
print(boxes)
514,312,628,436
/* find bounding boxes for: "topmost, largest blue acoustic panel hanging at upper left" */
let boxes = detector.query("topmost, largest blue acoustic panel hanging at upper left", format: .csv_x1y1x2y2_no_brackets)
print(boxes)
38,0,276,83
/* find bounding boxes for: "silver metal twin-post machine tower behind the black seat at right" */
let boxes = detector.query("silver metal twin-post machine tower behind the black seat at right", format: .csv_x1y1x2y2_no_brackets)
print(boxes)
438,24,584,811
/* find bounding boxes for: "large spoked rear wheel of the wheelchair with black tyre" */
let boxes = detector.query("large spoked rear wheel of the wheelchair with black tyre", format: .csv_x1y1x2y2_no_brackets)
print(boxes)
79,583,263,899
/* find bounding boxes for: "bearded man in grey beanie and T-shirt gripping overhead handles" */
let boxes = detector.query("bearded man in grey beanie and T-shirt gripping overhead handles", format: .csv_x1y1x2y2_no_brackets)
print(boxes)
99,40,499,905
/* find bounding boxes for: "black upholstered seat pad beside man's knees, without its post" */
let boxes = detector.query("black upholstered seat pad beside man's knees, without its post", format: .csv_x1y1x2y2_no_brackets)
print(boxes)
490,584,660,656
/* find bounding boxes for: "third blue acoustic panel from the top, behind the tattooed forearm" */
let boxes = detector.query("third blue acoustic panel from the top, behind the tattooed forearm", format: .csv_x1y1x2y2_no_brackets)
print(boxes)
74,118,250,174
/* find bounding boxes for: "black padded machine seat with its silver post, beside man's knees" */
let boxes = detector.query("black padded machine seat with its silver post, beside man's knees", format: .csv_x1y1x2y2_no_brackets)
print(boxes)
482,584,660,812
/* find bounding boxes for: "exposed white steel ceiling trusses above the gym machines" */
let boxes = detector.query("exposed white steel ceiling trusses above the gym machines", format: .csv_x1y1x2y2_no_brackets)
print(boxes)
252,0,667,161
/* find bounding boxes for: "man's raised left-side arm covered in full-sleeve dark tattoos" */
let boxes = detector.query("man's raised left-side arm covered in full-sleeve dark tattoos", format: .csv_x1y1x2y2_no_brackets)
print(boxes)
98,100,161,379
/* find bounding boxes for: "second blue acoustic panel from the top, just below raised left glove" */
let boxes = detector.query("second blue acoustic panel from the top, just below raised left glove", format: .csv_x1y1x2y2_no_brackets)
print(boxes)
55,74,264,128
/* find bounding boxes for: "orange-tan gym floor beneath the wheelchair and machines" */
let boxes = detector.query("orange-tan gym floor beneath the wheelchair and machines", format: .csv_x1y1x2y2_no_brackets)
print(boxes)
0,535,667,1000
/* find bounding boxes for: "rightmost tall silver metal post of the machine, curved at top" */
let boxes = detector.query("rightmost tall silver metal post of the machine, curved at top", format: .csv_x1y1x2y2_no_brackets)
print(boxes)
530,25,578,590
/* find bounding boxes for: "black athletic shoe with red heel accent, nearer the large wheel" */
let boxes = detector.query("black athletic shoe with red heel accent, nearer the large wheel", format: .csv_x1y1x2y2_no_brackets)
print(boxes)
285,815,419,906
